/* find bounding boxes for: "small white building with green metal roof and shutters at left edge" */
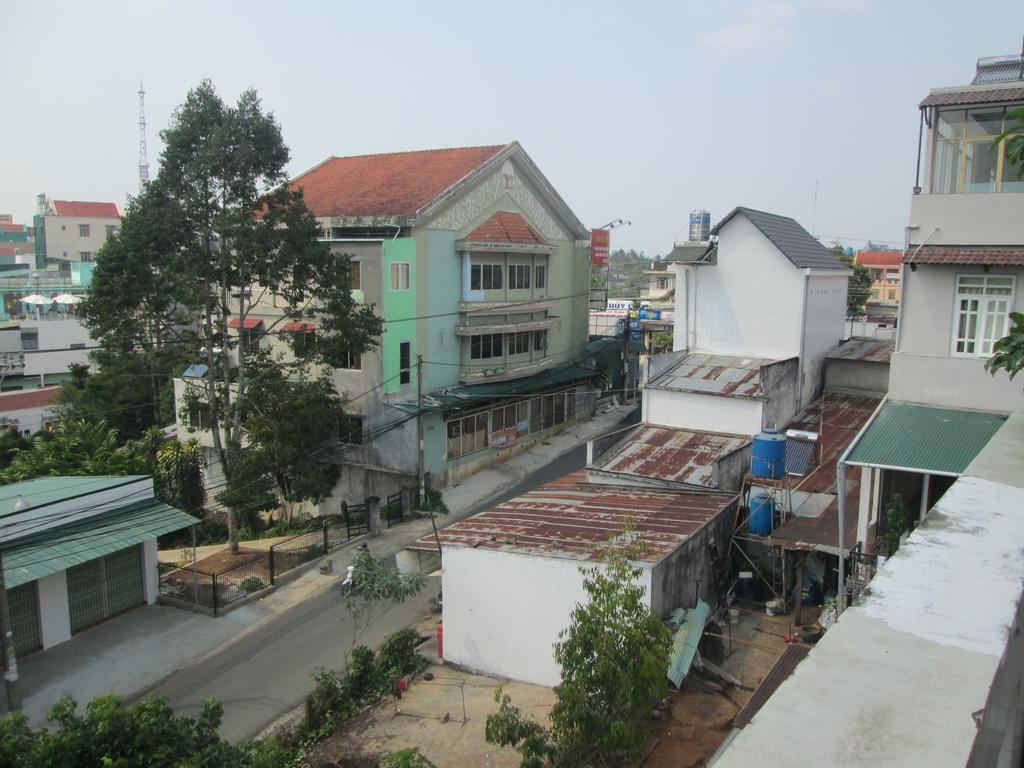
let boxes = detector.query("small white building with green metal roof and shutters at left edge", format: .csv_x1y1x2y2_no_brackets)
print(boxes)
0,475,199,656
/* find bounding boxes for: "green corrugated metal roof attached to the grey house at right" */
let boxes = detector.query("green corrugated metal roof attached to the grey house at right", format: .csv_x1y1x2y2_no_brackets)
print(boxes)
847,402,1007,475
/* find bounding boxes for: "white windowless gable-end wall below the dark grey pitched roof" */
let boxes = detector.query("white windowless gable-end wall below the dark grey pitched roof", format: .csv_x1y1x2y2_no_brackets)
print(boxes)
688,214,806,357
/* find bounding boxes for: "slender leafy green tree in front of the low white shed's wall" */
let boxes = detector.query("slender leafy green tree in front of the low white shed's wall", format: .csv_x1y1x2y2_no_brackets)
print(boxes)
486,549,672,768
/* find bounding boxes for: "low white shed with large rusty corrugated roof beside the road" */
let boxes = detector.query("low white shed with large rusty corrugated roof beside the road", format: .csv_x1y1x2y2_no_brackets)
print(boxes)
401,479,735,685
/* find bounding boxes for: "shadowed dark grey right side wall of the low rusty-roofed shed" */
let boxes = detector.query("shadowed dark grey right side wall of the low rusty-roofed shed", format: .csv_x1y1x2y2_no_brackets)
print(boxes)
651,497,736,616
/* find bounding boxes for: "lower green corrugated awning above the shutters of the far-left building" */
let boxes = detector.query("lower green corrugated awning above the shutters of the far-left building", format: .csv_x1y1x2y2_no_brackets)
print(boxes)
3,499,199,589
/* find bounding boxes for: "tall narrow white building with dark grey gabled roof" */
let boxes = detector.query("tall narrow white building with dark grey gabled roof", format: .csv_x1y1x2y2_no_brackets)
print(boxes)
663,207,851,432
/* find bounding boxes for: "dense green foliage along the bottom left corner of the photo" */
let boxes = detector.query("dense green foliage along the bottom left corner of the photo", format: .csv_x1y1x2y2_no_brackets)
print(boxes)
0,694,301,768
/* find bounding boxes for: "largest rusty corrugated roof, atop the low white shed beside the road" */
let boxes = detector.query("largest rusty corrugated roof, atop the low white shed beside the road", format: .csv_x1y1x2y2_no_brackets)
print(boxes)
409,471,735,566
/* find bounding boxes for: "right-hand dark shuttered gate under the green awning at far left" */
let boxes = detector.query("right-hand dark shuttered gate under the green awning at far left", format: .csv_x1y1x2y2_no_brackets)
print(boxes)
68,546,145,634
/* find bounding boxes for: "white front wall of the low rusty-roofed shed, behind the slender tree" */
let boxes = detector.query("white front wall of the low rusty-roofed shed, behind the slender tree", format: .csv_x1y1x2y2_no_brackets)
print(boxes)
441,545,650,686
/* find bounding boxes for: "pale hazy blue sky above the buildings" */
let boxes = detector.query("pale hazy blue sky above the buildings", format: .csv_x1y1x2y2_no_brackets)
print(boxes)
0,0,1024,256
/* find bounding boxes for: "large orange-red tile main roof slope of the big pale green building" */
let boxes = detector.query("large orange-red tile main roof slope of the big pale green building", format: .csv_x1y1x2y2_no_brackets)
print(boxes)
290,144,506,216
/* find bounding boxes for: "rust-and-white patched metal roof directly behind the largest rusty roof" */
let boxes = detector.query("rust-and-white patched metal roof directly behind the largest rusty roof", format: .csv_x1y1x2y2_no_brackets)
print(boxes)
588,424,751,487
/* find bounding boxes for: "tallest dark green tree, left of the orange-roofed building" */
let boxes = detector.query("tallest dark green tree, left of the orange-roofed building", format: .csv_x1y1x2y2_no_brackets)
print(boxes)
86,81,382,551
